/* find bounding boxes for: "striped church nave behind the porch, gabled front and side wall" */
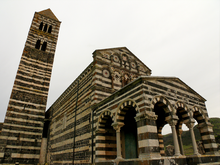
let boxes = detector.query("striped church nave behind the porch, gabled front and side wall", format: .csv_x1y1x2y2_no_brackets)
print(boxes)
45,47,151,164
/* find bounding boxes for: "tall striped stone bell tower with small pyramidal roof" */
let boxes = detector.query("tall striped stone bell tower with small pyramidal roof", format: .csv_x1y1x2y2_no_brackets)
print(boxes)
0,9,61,164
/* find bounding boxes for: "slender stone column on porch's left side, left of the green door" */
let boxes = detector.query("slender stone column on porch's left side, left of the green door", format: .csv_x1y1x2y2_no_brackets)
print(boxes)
112,122,124,161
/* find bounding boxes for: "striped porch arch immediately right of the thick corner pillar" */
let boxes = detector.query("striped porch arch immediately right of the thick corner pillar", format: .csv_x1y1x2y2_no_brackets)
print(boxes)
151,95,175,114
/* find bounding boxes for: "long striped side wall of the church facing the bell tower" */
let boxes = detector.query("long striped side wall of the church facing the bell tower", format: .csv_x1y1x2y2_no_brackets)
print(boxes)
47,63,94,164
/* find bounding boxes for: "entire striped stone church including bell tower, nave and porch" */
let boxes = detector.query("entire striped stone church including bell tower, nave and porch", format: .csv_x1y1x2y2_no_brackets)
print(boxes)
0,9,220,165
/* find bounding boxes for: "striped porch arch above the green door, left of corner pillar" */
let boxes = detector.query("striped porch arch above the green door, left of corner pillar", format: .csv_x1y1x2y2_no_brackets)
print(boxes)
115,99,140,122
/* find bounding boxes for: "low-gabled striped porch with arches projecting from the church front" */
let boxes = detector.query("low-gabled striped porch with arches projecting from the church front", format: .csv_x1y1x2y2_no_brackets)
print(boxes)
92,76,218,162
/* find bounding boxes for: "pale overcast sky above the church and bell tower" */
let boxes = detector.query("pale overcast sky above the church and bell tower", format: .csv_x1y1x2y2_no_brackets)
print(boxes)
0,0,220,134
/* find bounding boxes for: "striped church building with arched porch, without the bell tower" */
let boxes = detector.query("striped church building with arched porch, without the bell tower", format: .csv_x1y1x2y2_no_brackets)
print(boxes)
45,48,218,165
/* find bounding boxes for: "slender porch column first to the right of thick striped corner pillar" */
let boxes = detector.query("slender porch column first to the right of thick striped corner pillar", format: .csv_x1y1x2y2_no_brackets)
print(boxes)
168,118,181,156
